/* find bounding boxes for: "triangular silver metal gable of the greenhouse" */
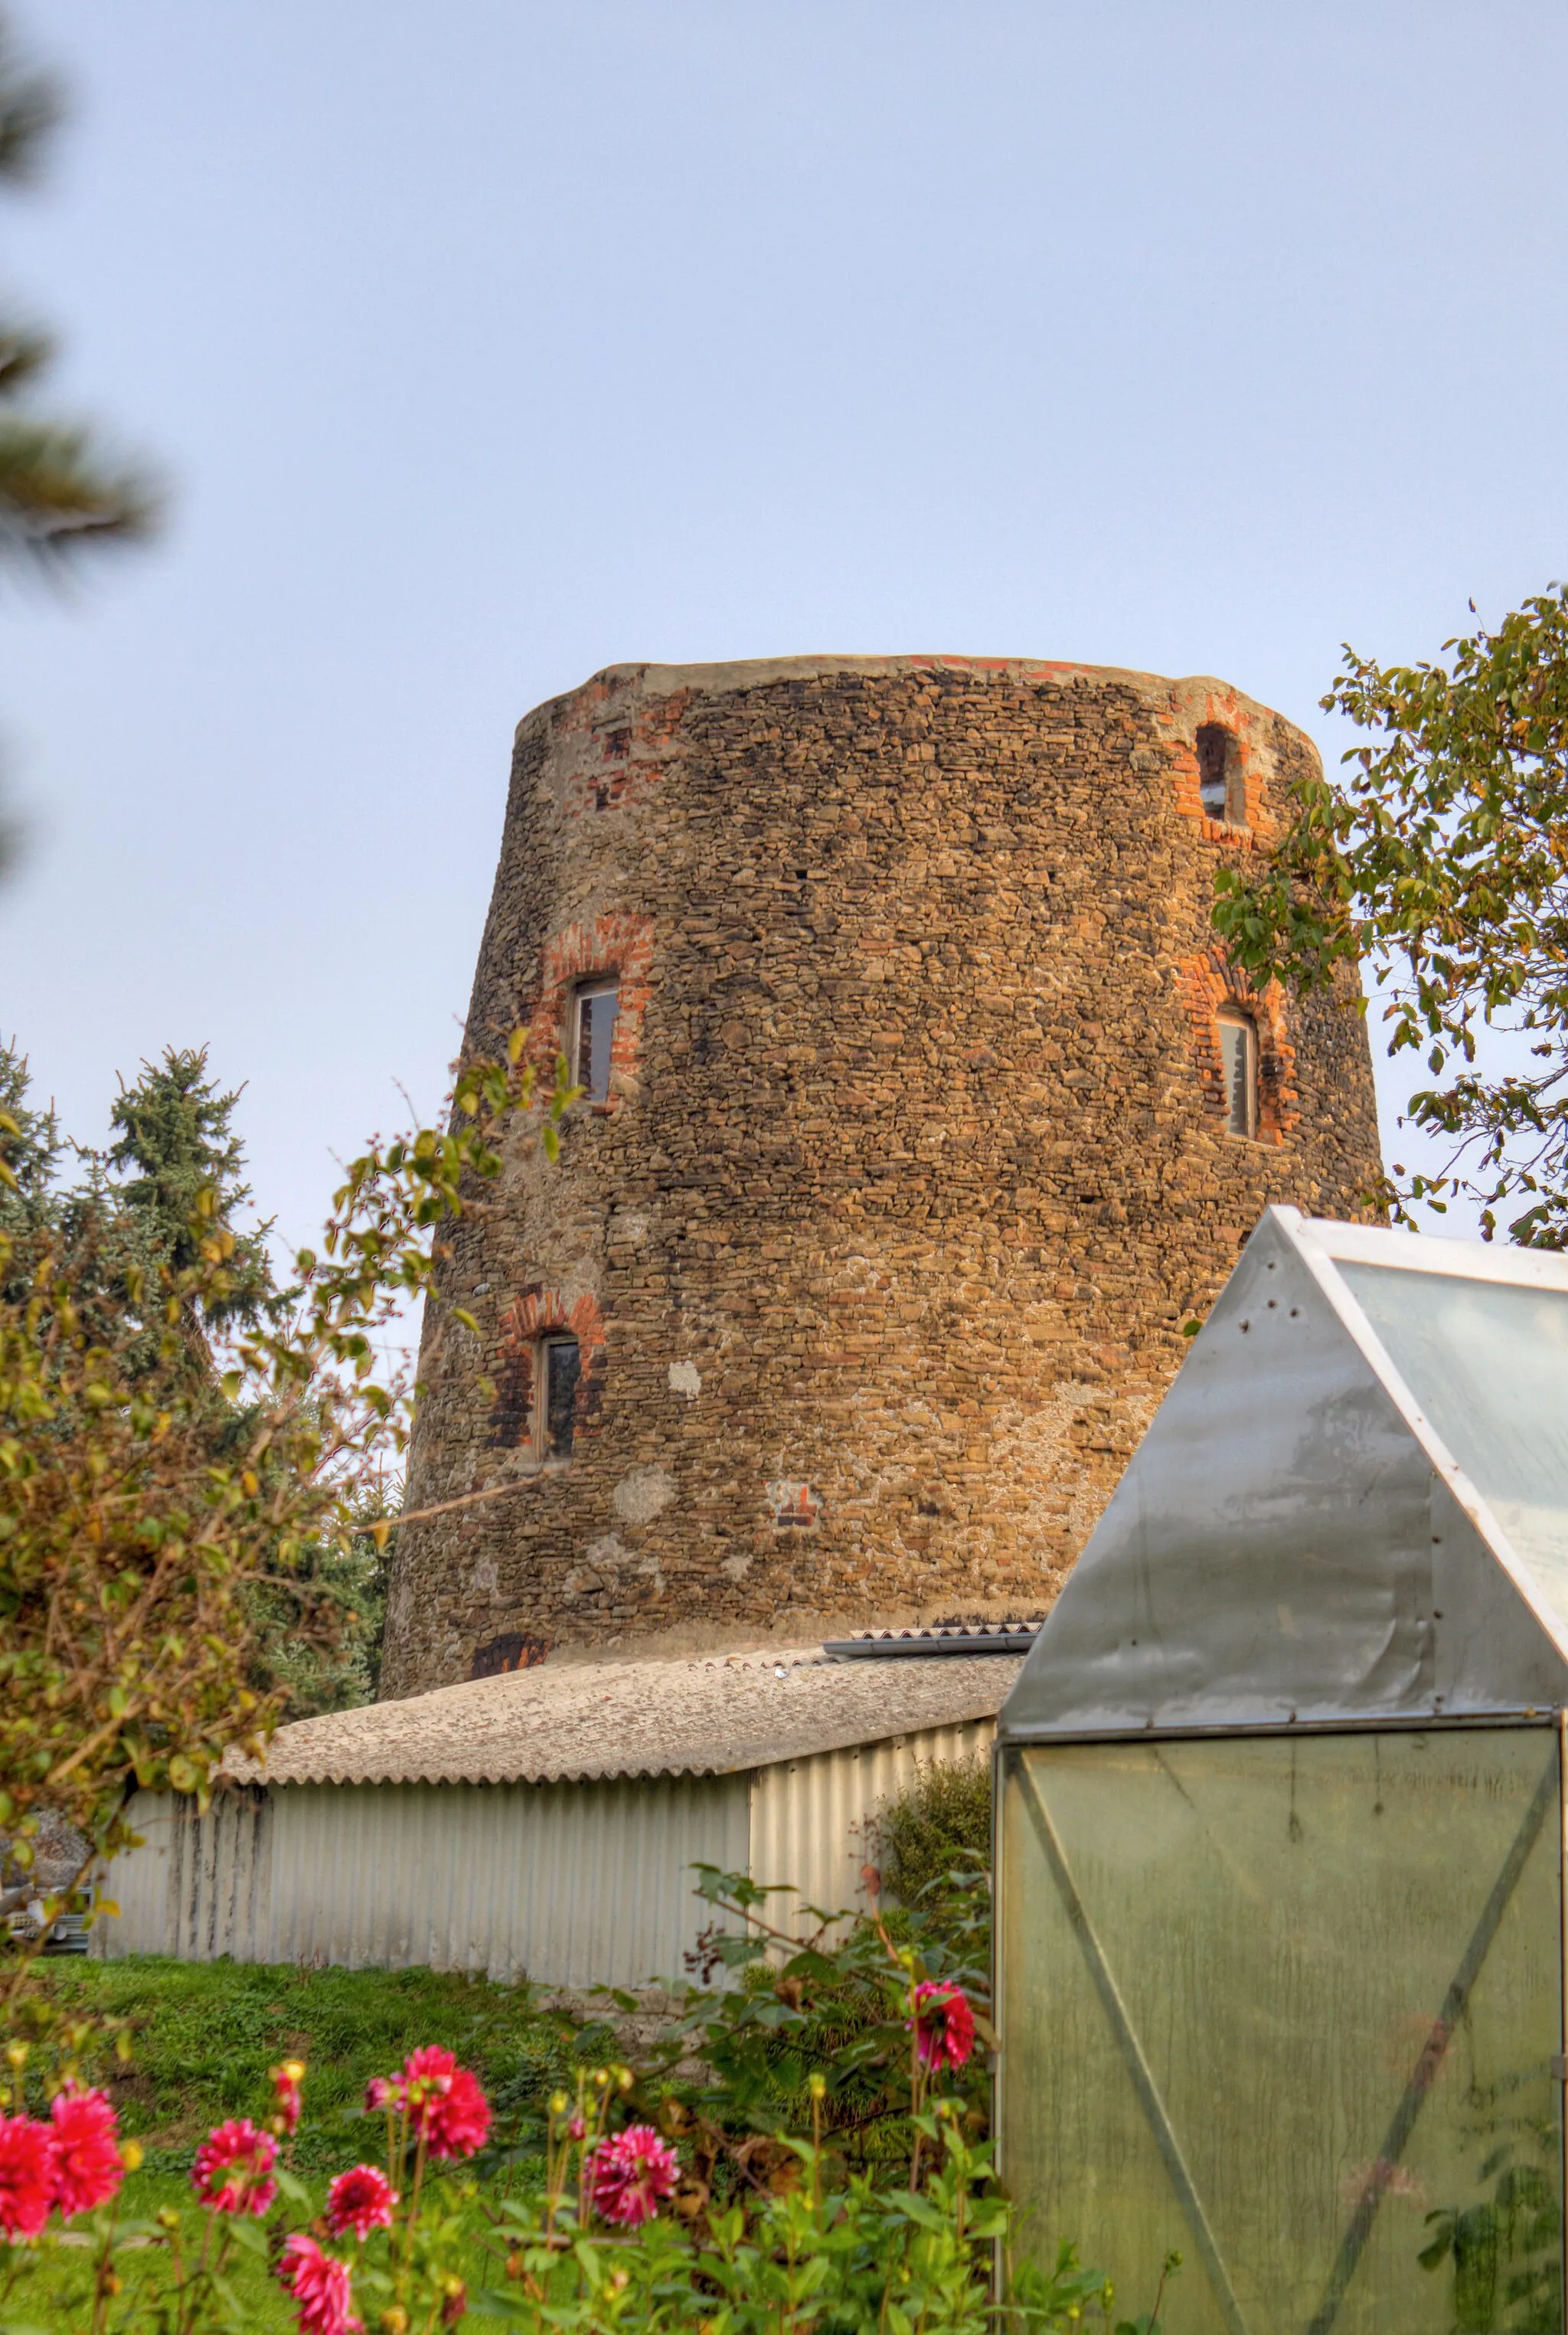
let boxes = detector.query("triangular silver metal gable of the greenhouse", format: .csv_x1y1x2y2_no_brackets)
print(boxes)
998,1209,1568,1742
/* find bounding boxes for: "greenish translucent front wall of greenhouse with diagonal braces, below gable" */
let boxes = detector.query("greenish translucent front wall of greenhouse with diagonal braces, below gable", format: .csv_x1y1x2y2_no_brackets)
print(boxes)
998,1728,1563,2335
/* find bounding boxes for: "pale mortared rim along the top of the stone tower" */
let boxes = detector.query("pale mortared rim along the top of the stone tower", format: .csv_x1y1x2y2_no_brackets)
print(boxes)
518,654,1300,728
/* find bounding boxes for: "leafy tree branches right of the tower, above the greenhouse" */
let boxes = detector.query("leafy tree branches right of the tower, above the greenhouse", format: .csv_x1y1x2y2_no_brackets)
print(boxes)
1214,584,1568,1249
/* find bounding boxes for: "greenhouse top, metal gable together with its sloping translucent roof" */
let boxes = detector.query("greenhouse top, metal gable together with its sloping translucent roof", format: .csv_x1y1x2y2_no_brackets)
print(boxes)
1001,1207,1568,1742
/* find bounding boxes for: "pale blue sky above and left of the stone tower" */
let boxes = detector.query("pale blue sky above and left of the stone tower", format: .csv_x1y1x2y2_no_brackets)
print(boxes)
0,0,1568,1238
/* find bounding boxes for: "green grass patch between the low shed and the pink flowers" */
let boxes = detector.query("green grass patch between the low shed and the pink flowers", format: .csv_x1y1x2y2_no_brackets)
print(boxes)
38,1957,614,2174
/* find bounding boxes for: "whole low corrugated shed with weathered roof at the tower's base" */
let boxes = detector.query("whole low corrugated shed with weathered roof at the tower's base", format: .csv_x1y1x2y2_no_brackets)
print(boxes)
96,1651,1020,1987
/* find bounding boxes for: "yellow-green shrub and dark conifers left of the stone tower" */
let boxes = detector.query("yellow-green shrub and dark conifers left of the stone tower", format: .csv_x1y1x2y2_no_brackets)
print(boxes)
0,1032,574,2062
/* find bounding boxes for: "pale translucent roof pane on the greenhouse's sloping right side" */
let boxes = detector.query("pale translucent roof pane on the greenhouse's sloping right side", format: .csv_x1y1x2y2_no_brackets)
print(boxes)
1339,1264,1568,1623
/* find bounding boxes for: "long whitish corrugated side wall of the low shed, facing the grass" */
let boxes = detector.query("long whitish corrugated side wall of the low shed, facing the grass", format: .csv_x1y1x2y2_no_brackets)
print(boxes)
98,1777,746,1987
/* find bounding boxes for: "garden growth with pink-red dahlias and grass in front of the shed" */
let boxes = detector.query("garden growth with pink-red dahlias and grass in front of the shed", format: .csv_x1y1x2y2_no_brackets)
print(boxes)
0,1868,1176,2335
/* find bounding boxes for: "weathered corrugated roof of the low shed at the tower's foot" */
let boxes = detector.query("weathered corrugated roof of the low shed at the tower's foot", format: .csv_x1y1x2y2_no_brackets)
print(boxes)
229,1647,1020,1784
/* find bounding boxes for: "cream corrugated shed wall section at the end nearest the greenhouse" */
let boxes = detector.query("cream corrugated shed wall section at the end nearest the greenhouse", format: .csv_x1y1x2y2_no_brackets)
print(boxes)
751,1719,996,1928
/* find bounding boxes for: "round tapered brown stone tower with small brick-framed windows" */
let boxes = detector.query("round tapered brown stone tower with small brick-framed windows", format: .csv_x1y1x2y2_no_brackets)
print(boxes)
385,656,1379,1696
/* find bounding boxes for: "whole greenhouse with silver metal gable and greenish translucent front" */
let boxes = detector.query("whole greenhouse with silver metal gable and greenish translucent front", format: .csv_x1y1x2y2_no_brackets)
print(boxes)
996,1207,1568,2335
